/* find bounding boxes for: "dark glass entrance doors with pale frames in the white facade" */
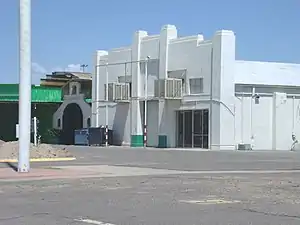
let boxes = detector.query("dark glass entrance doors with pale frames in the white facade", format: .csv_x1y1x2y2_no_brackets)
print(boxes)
177,109,209,148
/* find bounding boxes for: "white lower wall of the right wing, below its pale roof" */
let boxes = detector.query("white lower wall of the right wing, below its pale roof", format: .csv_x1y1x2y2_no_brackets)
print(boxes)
235,85,300,150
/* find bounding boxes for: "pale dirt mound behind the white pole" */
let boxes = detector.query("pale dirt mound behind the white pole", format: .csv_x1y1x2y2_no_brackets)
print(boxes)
0,141,72,159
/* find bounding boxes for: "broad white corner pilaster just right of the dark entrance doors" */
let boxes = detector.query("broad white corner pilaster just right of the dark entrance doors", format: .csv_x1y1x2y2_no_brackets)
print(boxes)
211,30,235,149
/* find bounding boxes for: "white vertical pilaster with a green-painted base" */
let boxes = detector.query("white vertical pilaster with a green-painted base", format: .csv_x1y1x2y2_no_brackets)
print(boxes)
131,31,148,147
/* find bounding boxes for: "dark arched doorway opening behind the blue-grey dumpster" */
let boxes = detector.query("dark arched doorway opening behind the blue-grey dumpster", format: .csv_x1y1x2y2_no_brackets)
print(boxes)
61,103,83,145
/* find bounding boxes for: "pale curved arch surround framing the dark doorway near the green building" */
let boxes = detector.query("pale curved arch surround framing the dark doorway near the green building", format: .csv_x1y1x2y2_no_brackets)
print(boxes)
53,95,91,129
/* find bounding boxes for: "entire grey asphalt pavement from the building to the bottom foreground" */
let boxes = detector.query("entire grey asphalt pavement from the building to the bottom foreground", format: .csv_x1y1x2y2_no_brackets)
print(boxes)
0,147,300,225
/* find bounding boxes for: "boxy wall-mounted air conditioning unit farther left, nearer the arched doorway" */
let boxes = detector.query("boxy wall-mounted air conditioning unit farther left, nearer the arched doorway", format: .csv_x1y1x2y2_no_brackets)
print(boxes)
104,83,131,102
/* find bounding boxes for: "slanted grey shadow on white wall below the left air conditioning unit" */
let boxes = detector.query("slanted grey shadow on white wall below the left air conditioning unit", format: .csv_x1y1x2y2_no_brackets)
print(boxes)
113,103,129,146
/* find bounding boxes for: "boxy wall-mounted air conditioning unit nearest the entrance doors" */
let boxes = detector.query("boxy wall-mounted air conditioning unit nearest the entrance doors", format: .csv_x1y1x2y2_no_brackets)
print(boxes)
154,78,182,99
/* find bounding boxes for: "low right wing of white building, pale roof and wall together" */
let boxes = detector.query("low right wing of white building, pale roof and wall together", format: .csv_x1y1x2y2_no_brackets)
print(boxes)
234,61,300,150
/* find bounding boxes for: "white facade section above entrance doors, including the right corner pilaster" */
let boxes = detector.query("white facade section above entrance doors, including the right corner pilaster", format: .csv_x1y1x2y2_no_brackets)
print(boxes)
169,28,235,149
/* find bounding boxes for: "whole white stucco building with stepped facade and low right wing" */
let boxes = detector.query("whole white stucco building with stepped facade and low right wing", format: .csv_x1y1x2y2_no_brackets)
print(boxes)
92,25,300,150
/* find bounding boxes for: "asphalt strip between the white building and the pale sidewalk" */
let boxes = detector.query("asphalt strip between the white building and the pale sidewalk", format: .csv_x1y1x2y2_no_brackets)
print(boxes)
39,147,300,170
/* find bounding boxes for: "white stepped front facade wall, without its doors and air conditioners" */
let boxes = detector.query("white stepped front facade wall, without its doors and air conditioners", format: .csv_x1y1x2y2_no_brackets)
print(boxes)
92,25,235,149
